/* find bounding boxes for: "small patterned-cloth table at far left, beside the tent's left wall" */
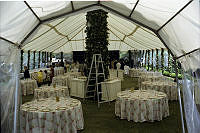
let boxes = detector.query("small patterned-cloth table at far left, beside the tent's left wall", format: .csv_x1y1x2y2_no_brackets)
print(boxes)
20,79,38,96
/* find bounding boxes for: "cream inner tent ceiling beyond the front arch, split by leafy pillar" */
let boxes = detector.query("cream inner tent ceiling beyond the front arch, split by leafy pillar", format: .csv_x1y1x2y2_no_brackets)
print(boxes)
22,13,164,53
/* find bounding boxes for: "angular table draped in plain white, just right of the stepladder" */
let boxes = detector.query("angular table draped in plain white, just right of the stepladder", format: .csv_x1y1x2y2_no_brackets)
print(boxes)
101,79,121,101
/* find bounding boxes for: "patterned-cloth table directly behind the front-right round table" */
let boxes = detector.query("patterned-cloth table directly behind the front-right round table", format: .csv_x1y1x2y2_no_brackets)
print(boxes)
141,81,178,100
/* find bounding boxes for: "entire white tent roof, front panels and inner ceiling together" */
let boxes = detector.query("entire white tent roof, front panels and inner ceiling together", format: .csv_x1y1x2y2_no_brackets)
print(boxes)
0,0,200,69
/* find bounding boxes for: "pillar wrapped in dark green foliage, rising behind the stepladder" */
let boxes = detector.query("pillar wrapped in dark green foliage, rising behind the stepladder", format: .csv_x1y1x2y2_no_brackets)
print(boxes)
85,9,109,78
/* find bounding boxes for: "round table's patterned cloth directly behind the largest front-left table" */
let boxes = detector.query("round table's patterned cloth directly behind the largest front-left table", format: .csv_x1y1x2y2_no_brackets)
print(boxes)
34,85,69,99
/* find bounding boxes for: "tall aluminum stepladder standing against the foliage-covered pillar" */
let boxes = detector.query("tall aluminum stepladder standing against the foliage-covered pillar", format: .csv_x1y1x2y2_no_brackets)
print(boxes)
85,54,110,108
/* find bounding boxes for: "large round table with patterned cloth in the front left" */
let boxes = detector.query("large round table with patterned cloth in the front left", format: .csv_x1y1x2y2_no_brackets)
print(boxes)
20,98,84,133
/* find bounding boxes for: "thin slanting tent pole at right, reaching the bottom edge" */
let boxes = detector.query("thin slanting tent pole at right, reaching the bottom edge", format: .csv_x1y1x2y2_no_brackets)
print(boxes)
174,58,185,133
